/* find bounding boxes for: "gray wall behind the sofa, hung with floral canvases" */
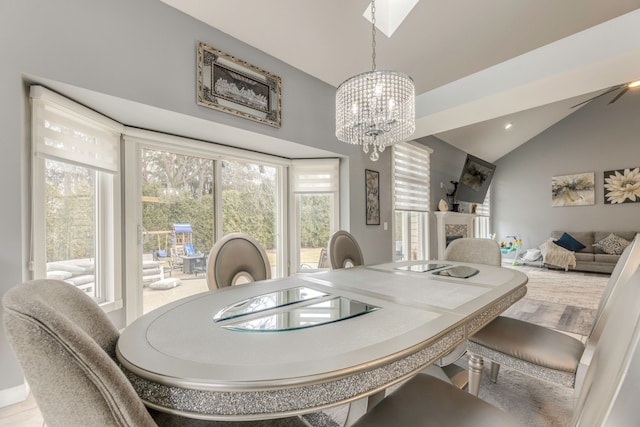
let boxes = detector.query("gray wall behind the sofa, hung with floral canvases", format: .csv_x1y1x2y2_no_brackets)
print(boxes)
492,91,640,248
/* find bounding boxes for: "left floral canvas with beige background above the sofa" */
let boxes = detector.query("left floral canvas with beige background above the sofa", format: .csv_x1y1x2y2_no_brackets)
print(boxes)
551,172,595,206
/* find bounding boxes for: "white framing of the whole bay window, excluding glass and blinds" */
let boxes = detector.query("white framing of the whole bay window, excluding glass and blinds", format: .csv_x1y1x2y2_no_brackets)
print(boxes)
29,86,341,324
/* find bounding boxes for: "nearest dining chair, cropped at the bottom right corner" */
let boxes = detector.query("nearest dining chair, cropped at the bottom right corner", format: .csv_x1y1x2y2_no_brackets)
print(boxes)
352,269,640,427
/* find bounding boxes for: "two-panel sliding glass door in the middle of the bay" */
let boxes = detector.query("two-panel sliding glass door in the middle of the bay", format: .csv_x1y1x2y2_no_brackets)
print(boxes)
124,132,289,321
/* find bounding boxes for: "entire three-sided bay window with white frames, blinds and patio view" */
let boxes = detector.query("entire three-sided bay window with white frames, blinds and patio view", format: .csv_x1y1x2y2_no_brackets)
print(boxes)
31,86,339,323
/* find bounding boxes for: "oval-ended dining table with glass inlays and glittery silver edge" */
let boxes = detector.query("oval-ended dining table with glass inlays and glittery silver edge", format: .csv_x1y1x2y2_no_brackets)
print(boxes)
116,261,527,421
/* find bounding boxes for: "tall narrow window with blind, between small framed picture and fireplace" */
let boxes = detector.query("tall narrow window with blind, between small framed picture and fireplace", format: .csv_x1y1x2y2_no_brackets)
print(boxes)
393,142,431,261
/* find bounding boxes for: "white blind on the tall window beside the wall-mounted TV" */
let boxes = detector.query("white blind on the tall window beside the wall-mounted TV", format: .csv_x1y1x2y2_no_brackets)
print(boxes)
393,142,431,212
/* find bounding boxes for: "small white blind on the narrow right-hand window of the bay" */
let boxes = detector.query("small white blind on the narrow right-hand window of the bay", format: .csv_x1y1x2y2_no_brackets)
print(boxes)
290,159,340,193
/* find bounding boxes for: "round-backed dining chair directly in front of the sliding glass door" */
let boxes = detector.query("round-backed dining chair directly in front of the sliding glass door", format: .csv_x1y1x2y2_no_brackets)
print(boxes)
207,233,271,290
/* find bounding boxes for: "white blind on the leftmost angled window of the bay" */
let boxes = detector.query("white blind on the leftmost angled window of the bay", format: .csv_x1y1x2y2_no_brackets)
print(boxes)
31,86,123,173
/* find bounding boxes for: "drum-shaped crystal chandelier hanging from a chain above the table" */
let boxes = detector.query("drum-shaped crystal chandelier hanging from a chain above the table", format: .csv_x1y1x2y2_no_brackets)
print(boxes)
336,0,416,162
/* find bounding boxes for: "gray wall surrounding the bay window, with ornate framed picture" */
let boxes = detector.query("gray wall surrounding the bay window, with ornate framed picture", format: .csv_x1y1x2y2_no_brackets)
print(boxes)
0,0,393,398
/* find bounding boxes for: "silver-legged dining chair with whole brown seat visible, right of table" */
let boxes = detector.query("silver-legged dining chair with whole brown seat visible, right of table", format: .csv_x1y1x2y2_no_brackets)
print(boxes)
468,235,640,395
